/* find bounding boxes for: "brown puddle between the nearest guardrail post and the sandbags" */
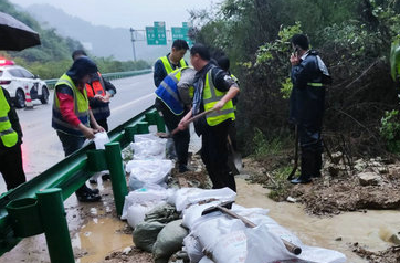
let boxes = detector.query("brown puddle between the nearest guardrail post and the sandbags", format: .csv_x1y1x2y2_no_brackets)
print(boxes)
72,218,133,263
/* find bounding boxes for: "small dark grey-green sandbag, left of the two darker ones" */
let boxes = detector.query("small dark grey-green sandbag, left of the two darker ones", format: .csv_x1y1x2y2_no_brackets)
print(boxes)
133,222,165,252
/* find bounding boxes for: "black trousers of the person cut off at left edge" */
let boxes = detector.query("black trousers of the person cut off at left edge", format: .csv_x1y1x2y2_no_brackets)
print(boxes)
0,144,26,190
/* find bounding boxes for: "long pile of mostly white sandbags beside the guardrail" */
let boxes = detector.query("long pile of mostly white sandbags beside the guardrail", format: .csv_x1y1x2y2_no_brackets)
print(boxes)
122,135,346,263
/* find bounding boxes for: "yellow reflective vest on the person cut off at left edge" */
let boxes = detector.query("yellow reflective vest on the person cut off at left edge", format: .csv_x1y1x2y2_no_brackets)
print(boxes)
0,87,18,147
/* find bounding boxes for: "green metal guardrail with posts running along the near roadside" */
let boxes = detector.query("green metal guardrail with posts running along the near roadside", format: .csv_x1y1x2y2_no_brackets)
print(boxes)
0,106,165,263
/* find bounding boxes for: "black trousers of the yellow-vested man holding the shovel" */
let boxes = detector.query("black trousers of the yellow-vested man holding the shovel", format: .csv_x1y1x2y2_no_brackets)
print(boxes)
201,120,236,191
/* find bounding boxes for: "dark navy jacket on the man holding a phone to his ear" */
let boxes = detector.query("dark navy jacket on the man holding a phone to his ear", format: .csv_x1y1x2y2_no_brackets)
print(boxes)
290,51,329,129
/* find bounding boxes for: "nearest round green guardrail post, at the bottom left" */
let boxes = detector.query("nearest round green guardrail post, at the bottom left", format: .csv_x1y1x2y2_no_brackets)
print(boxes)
36,188,75,263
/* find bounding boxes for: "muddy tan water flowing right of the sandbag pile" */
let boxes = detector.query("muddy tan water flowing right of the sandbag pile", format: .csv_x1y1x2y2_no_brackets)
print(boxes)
236,179,400,263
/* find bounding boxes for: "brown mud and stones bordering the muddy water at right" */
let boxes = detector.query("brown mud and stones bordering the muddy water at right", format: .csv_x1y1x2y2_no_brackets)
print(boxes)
244,156,400,263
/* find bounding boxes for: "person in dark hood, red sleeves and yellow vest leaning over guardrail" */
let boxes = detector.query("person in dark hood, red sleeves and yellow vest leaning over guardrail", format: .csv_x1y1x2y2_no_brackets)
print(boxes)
52,56,105,202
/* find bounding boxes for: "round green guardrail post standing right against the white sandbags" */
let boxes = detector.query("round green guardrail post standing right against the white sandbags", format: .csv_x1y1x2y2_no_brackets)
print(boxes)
105,143,128,218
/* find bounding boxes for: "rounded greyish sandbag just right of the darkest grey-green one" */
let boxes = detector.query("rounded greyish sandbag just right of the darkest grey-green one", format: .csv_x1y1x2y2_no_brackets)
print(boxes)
153,220,188,263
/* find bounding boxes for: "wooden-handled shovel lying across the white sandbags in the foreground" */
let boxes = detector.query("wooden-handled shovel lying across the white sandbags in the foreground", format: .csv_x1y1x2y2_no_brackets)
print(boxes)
201,202,302,255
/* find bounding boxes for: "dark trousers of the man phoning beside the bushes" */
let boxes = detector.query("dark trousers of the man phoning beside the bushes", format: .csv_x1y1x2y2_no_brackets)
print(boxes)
298,125,324,179
